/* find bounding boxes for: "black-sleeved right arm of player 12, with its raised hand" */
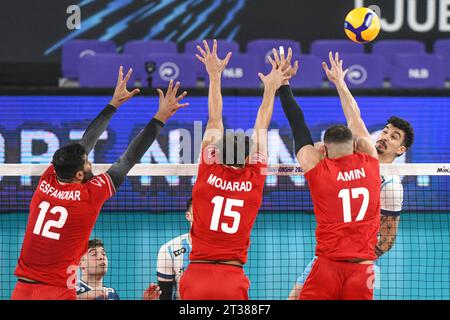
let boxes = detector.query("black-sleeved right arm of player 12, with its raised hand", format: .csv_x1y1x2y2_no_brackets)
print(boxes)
107,80,189,190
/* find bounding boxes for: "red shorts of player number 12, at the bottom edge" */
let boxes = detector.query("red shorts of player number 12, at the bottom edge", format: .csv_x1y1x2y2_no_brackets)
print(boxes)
11,281,77,300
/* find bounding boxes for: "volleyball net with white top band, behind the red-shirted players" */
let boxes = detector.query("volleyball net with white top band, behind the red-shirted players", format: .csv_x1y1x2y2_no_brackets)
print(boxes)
0,164,450,300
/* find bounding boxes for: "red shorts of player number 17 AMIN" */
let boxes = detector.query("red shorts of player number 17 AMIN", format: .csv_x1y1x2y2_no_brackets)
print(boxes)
299,257,375,300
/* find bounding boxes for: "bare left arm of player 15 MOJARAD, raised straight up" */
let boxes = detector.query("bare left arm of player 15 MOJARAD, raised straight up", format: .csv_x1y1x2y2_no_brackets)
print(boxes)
195,40,231,148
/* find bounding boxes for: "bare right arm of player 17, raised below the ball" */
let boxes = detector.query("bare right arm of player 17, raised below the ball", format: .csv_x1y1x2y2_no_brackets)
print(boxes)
322,52,370,138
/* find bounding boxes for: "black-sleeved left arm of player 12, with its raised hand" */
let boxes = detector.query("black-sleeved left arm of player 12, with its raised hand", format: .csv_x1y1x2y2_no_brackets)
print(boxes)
80,66,140,154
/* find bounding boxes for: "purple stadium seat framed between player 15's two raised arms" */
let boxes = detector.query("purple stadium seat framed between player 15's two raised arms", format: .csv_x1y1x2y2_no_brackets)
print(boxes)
214,54,261,89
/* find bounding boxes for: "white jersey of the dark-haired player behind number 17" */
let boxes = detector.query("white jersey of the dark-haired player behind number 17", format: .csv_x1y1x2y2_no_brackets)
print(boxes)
380,175,403,216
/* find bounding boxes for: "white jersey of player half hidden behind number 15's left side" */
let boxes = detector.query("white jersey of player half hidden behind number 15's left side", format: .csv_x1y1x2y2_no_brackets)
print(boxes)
156,233,192,299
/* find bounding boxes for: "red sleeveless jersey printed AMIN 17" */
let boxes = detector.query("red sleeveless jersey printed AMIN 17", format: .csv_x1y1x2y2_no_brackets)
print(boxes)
305,153,381,260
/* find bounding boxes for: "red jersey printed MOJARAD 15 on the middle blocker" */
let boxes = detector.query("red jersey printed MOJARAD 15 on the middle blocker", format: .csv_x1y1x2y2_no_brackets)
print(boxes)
189,145,267,263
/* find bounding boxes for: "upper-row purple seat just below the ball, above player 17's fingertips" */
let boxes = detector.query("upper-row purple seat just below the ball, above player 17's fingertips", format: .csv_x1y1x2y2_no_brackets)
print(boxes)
310,40,364,62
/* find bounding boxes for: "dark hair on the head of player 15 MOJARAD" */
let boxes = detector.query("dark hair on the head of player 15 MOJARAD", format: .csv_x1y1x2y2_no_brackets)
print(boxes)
219,132,250,167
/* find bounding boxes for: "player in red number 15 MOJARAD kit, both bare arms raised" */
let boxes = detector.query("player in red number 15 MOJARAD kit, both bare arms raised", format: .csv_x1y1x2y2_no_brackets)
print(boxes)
180,40,292,300
